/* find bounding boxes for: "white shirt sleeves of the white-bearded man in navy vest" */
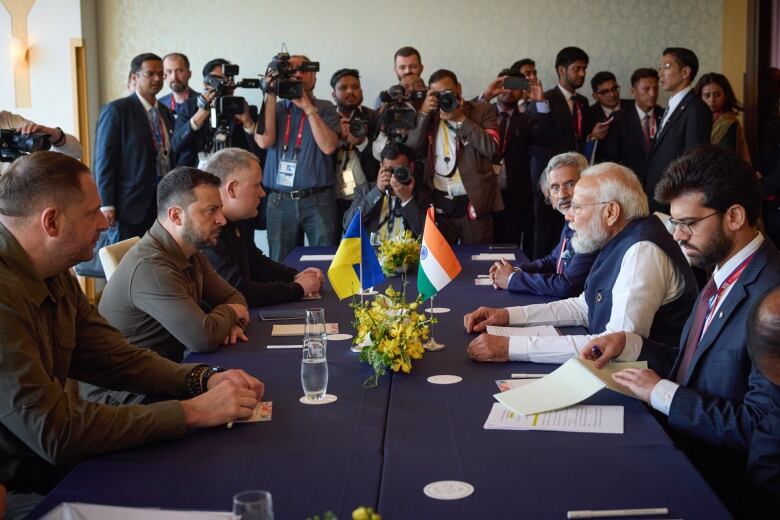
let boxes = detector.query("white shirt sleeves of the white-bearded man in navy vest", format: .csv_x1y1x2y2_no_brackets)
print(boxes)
507,241,685,363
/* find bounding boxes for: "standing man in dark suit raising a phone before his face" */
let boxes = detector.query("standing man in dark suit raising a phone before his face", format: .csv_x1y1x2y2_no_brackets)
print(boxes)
480,69,554,256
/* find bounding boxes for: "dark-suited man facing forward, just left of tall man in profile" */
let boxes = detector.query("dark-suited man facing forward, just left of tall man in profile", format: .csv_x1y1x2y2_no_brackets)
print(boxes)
599,68,663,175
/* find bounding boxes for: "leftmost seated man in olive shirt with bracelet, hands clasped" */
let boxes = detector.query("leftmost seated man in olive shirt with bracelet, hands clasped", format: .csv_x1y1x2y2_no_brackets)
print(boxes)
0,152,263,518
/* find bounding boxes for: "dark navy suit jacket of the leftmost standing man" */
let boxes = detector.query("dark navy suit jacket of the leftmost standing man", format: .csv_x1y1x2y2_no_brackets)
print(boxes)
94,93,176,224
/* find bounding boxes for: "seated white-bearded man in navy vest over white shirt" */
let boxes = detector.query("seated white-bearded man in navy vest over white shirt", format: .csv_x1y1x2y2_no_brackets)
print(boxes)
463,163,698,363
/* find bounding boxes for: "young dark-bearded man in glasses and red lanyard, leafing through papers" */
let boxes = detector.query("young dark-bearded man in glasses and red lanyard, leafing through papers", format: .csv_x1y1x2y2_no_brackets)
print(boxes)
582,145,780,516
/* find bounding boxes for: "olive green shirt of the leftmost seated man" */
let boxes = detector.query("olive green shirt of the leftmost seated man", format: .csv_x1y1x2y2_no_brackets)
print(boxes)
0,224,195,493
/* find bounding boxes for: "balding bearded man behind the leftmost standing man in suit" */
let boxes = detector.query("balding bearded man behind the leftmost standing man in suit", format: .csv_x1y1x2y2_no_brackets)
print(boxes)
158,52,200,166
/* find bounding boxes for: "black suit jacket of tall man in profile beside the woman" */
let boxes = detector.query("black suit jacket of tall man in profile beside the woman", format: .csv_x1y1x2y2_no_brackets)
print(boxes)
640,90,712,213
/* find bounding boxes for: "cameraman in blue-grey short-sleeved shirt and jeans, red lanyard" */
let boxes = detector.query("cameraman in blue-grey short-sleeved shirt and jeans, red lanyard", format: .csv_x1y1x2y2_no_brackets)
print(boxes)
255,53,340,262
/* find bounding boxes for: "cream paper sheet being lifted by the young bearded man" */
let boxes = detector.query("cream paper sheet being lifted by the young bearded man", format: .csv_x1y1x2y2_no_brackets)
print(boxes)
493,358,647,416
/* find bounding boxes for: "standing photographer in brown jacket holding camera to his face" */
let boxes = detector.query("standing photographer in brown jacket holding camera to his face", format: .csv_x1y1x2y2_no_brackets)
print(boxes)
407,69,504,244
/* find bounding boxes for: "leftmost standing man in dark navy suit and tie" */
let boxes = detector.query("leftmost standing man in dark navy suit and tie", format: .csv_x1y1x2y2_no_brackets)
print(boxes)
95,53,175,241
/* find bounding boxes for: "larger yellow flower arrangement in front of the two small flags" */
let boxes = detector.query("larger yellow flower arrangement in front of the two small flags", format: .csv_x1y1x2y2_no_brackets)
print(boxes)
350,284,435,388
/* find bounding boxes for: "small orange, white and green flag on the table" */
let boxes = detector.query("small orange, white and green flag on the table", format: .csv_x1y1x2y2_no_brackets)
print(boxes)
417,207,460,300
